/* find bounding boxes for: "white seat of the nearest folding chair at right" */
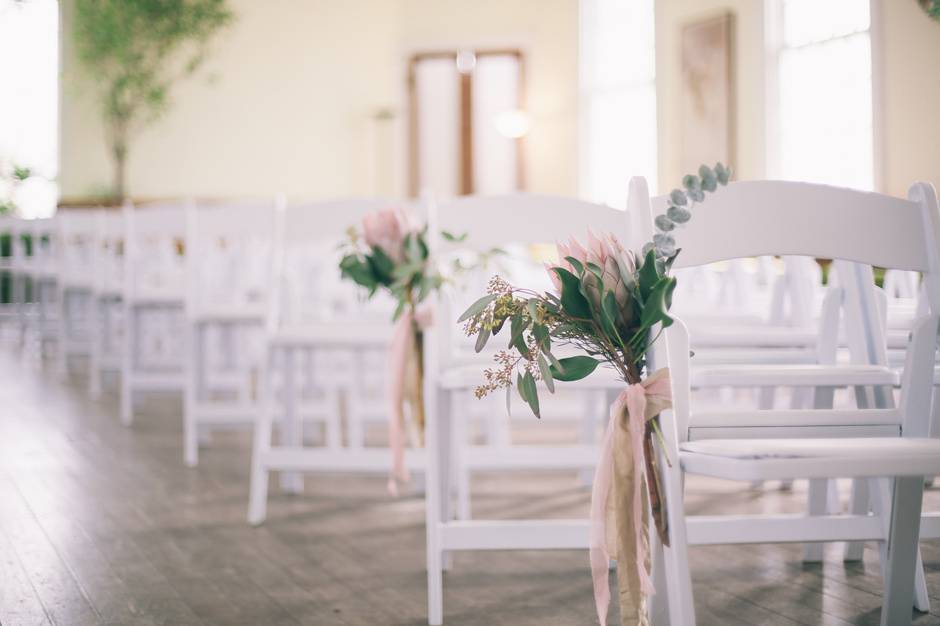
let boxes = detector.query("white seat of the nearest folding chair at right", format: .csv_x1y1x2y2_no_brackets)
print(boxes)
679,437,940,481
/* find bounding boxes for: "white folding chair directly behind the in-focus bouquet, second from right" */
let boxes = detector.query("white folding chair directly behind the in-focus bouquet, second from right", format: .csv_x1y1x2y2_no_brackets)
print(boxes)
425,194,629,624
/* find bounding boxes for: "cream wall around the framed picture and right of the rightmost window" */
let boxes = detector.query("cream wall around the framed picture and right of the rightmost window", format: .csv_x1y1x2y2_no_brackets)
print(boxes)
656,0,940,196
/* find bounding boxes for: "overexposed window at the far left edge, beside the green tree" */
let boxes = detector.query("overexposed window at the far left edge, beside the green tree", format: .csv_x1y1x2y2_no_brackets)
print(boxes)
0,0,59,217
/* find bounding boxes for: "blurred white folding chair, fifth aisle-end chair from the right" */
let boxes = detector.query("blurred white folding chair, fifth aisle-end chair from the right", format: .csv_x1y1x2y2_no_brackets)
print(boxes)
120,204,187,425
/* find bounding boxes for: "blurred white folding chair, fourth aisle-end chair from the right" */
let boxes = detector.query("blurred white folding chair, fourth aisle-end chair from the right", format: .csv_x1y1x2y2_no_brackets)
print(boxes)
183,197,283,467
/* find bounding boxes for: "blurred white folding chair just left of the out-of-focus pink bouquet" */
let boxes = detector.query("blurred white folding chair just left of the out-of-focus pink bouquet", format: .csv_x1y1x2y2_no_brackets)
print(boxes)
248,199,400,524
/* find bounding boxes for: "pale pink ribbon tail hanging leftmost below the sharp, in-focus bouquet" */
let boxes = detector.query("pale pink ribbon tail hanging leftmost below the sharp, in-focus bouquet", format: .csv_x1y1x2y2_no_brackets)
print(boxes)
590,410,619,626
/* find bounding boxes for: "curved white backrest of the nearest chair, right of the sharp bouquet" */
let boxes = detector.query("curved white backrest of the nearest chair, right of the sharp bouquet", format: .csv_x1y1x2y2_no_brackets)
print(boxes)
632,174,940,436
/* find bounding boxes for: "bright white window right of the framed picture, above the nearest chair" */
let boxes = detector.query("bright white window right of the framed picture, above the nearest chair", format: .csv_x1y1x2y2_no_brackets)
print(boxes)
768,0,875,190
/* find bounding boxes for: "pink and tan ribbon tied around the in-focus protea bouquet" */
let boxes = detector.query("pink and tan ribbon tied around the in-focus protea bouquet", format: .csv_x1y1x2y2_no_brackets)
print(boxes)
590,368,672,626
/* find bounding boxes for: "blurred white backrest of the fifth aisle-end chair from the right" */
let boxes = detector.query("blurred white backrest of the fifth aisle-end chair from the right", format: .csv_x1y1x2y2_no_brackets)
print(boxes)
123,202,192,303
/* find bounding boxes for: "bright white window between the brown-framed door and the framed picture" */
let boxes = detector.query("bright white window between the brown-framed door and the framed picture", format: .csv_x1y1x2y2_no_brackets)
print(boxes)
580,0,657,207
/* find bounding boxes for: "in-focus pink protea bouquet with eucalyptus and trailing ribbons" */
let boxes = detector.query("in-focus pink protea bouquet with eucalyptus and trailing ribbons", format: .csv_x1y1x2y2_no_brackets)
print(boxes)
458,163,731,624
